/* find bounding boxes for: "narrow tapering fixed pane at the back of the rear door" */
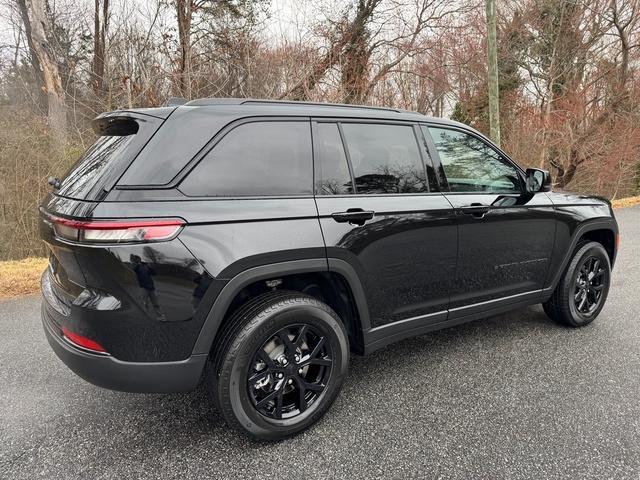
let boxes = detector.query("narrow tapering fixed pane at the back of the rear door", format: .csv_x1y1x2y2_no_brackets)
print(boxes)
315,123,353,195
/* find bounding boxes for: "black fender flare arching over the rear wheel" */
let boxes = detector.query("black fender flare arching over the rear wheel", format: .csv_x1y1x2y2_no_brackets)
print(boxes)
192,258,371,355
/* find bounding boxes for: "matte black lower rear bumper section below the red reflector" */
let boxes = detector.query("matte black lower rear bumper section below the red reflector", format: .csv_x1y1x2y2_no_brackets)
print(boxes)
42,300,207,393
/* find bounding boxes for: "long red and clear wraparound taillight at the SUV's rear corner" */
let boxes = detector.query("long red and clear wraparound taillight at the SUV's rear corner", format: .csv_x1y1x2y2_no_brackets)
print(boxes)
48,215,184,243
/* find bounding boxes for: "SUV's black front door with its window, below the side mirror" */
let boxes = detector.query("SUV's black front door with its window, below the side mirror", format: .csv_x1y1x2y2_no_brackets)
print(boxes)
422,125,555,316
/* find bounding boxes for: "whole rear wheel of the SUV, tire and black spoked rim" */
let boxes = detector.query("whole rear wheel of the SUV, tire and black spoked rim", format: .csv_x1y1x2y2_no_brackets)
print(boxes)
205,291,349,441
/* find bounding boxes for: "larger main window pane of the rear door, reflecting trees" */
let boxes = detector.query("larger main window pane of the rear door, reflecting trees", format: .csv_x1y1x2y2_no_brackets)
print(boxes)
342,123,429,193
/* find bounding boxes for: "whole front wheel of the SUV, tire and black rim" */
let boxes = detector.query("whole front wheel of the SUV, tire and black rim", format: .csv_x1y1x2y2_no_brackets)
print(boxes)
542,242,611,327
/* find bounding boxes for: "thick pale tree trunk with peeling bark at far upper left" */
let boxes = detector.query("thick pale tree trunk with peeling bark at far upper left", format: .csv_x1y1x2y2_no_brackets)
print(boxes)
18,0,67,152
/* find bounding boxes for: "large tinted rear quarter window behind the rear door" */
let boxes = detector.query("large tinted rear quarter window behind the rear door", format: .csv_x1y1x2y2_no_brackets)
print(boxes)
180,122,312,197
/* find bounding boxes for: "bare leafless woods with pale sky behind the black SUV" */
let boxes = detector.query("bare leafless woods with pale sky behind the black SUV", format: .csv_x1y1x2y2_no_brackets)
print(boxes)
0,0,640,260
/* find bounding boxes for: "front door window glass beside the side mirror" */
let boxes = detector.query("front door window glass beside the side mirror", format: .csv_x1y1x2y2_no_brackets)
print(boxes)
423,127,522,193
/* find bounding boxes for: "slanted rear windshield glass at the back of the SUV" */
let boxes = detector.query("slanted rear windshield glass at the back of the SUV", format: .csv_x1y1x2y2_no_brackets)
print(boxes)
55,117,161,200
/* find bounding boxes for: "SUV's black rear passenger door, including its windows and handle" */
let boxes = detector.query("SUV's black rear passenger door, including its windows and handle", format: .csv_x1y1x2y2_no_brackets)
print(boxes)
313,119,457,328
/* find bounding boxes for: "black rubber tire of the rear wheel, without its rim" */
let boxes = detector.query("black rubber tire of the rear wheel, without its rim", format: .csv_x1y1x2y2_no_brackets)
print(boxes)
218,298,349,440
